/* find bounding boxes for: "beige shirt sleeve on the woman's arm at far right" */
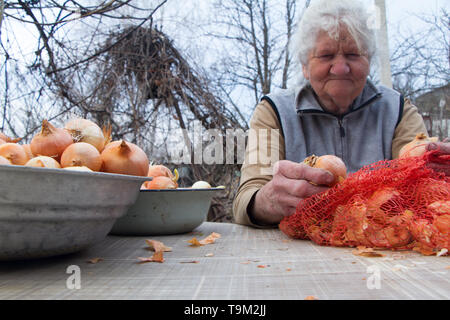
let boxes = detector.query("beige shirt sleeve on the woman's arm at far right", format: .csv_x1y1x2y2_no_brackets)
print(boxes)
392,99,428,159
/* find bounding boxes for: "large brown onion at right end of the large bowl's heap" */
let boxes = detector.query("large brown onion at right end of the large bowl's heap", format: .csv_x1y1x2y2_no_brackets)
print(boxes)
101,140,149,177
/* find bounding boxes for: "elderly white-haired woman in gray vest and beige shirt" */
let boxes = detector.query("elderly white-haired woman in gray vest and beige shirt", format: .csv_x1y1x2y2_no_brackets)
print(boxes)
233,0,450,227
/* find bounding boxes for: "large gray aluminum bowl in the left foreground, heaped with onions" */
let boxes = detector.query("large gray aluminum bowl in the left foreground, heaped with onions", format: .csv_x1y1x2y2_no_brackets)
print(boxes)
0,165,149,261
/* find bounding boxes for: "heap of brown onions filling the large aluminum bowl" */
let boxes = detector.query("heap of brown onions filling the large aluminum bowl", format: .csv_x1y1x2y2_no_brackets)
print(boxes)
0,118,153,179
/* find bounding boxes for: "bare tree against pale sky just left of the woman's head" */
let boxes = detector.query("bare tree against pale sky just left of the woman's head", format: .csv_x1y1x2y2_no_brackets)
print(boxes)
208,0,297,107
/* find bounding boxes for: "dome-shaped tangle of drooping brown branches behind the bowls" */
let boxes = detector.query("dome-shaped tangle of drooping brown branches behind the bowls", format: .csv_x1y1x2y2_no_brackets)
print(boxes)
92,27,247,221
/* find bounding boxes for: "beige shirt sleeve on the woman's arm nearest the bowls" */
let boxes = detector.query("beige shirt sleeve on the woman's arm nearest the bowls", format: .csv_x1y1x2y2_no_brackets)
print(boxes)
233,100,285,228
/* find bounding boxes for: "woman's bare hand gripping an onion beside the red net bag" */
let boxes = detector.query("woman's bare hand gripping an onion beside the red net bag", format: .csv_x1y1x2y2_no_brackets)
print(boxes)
249,160,334,225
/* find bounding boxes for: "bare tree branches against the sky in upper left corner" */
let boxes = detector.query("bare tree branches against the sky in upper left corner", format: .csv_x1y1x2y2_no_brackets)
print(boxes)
0,0,167,140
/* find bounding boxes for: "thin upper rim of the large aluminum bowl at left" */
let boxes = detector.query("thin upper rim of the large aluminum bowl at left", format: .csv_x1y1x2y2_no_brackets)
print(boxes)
0,164,152,182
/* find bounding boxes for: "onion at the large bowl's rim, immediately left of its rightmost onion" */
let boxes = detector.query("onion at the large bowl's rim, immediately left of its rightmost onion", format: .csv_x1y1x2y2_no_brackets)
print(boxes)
61,142,102,171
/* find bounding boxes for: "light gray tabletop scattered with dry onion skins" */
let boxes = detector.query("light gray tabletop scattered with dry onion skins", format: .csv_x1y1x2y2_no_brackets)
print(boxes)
0,222,450,300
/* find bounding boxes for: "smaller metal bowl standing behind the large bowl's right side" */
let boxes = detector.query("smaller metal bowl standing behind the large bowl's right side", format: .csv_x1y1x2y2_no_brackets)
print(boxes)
111,188,224,236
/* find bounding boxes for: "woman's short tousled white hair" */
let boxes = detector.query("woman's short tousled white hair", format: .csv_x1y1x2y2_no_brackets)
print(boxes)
292,0,376,65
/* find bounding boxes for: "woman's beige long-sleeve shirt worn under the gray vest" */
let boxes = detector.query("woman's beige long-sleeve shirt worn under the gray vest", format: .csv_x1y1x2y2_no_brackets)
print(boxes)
233,99,427,227
